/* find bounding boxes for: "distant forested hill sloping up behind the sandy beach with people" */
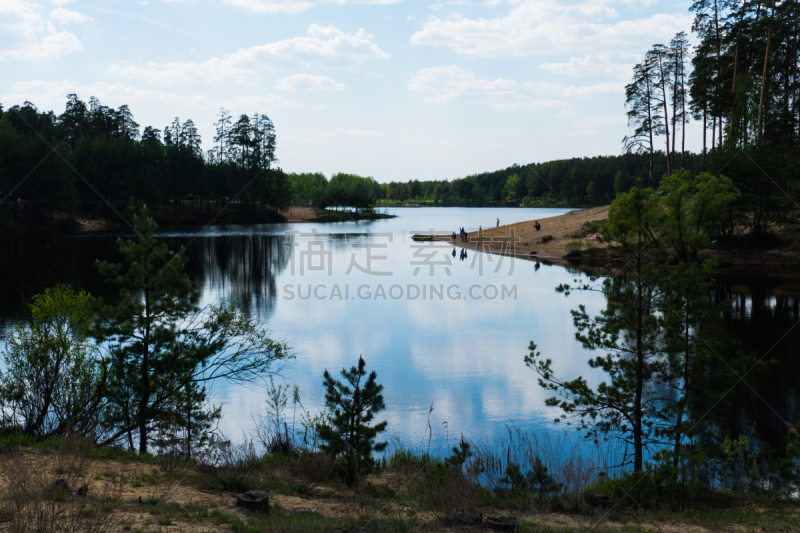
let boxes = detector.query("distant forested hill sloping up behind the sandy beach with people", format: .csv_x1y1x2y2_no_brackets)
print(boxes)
376,152,703,206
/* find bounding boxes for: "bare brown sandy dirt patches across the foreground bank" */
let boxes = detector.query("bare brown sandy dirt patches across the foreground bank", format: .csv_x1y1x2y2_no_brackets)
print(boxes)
0,451,768,533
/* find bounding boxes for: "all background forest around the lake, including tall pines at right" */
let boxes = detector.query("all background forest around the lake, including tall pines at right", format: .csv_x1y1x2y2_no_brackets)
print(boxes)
0,0,800,222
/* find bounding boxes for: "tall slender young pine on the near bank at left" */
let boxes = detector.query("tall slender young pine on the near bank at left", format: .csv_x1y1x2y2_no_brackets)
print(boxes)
97,209,198,453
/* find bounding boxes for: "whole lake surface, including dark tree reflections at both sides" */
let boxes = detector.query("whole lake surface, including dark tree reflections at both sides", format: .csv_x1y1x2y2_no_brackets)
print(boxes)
0,208,800,453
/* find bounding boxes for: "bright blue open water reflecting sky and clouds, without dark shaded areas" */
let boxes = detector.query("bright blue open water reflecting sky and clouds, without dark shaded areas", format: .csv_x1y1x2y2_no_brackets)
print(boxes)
177,208,604,452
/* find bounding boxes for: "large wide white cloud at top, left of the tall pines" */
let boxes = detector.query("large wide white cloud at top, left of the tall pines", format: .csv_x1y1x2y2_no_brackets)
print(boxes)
410,0,692,58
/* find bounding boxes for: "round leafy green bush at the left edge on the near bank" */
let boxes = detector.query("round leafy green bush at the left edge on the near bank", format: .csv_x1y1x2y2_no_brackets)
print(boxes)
0,285,107,437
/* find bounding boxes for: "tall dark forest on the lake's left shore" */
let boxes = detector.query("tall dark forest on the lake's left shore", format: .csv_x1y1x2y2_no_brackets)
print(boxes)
0,94,291,217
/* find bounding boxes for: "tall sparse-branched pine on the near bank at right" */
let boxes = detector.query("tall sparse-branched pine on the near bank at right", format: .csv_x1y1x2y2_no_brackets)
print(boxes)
525,187,666,472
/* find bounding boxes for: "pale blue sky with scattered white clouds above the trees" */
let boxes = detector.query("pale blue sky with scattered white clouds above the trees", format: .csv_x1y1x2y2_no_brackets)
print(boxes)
0,0,702,182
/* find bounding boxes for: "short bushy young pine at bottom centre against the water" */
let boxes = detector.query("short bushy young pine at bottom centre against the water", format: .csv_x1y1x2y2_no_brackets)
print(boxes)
319,357,387,483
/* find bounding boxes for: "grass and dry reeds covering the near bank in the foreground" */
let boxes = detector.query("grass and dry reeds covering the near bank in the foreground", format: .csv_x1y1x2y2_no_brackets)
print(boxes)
0,432,800,533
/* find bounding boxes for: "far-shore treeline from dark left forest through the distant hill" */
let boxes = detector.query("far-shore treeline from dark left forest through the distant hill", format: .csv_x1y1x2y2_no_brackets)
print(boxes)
0,94,702,217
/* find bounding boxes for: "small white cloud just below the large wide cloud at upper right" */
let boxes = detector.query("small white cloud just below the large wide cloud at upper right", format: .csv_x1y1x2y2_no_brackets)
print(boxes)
408,65,517,104
